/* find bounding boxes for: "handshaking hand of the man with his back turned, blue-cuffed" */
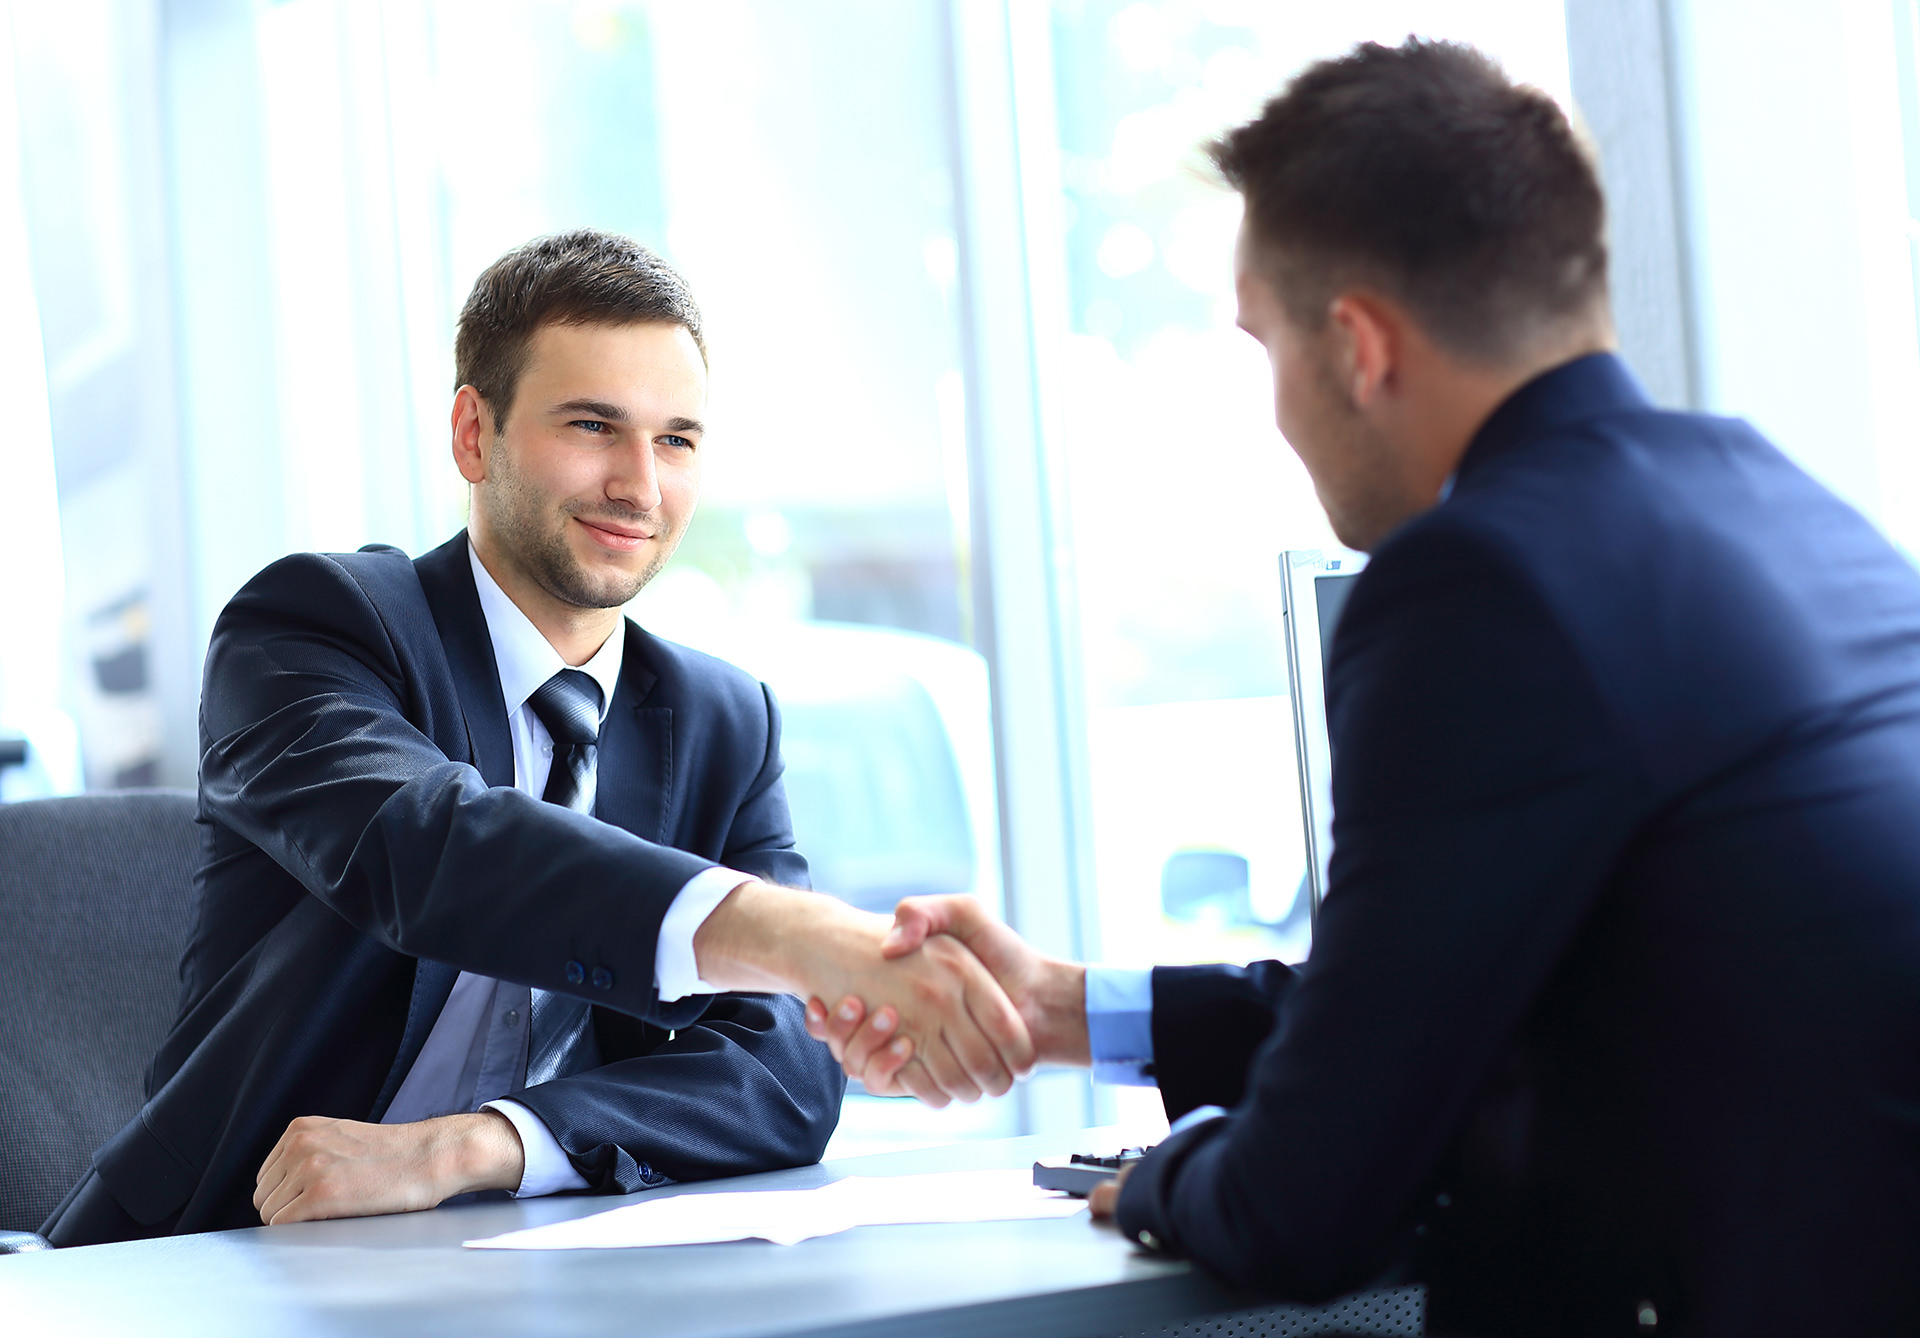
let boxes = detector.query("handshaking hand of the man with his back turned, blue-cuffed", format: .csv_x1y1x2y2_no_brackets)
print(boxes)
806,896,1091,1096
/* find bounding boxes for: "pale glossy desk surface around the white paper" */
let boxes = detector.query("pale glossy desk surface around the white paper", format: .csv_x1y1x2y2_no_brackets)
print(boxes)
0,1135,1417,1338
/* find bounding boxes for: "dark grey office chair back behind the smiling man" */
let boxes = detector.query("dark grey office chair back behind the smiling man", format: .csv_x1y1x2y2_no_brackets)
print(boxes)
0,789,198,1254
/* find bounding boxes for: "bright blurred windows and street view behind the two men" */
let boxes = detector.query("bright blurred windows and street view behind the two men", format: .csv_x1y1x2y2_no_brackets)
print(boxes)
0,0,1920,1152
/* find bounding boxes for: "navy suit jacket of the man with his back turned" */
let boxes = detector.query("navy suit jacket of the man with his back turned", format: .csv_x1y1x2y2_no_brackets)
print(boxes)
1119,355,1920,1336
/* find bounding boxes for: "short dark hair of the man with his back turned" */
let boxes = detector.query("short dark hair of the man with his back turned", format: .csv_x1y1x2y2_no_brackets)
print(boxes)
1208,36,1607,361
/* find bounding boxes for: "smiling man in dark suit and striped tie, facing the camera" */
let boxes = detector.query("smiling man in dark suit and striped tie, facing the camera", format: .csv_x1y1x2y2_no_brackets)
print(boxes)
46,230,1031,1244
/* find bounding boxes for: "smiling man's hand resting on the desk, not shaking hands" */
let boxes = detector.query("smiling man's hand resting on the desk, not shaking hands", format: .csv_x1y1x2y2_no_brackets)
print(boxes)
253,1110,526,1227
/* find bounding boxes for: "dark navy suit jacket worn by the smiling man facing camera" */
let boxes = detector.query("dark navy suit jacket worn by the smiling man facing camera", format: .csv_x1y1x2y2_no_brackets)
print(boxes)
61,534,843,1244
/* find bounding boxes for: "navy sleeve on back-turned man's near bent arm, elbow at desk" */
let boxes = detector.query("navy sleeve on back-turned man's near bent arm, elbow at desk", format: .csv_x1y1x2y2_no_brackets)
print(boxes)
1119,524,1647,1300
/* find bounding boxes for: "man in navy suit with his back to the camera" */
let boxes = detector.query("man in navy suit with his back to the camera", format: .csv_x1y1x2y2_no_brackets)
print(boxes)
808,40,1920,1338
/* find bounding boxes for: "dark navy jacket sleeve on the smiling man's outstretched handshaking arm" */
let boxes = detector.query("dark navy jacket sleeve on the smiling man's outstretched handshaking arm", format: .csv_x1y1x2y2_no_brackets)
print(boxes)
200,553,710,1025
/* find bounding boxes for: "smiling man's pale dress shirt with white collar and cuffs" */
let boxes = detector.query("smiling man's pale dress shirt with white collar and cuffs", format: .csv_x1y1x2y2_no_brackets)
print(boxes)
382,541,749,1198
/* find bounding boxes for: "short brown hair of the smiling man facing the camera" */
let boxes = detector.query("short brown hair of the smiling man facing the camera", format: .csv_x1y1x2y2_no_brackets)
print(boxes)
453,228,707,426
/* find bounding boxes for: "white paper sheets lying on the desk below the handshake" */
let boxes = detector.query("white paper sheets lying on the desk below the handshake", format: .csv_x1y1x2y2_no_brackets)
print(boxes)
465,1171,1087,1250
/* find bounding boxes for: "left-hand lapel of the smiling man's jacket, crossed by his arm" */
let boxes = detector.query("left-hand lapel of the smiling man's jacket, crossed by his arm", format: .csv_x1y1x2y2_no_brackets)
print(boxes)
372,530,513,1119
